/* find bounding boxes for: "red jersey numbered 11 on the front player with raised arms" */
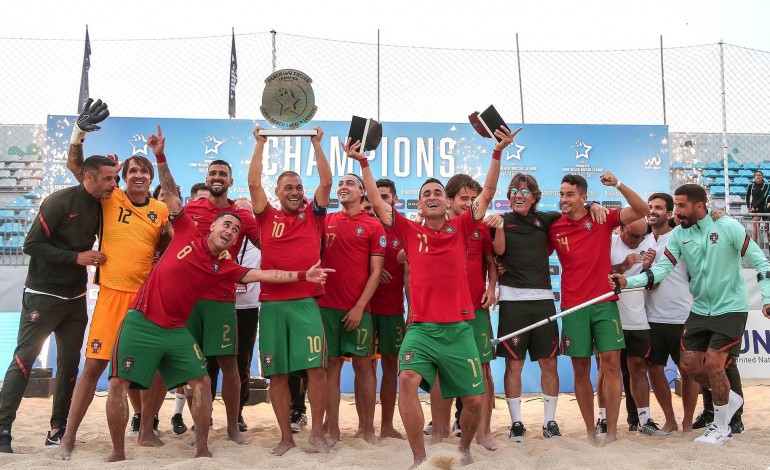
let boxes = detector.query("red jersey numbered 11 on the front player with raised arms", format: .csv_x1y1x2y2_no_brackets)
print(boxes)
393,211,478,323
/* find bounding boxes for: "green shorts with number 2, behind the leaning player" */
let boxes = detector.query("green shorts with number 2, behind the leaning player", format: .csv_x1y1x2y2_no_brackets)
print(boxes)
187,299,238,357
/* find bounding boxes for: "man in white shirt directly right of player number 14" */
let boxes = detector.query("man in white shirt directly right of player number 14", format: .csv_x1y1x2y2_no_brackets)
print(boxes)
600,219,666,436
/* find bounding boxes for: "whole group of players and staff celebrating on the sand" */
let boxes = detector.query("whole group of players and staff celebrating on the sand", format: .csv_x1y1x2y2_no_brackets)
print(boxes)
0,100,770,466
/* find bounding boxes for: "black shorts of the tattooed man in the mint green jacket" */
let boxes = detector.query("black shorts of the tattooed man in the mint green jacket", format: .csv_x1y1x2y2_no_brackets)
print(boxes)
682,312,749,357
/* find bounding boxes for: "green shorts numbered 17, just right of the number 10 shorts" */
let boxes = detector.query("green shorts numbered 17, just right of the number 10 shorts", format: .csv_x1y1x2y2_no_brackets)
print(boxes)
321,307,374,357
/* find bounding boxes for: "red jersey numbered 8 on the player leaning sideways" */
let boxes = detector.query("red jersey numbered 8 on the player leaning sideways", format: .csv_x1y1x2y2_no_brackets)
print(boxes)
131,210,251,328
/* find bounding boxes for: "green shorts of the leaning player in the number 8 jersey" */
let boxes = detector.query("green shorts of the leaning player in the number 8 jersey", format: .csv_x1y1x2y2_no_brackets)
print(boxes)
110,309,208,390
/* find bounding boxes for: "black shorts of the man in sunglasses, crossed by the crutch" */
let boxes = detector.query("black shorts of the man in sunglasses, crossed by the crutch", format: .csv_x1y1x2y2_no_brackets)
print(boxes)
495,299,559,361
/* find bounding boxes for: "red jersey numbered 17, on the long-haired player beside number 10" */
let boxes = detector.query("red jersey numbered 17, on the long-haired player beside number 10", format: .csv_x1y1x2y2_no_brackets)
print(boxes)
318,212,386,310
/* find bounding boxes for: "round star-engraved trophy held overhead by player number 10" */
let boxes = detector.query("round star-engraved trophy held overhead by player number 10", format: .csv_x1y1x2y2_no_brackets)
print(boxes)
259,69,318,136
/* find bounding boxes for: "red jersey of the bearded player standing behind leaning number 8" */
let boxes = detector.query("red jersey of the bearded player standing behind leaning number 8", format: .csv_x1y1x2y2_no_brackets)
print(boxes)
185,199,259,302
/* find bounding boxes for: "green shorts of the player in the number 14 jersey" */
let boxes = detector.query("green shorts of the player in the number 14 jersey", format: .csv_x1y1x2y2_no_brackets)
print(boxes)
561,302,626,357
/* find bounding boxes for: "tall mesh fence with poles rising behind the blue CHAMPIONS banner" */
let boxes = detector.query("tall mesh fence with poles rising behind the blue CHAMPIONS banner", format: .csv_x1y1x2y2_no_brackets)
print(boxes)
0,31,770,266
